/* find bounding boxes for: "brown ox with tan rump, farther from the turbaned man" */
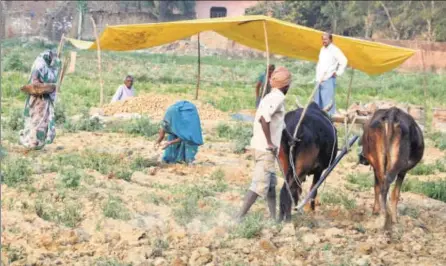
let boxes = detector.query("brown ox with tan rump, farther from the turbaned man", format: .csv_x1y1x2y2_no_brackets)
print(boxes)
362,107,424,230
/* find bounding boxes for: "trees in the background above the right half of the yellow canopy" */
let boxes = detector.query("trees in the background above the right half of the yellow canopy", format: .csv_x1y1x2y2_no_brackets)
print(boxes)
246,1,446,41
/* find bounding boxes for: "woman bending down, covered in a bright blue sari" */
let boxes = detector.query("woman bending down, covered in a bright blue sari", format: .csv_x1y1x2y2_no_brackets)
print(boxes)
155,101,203,164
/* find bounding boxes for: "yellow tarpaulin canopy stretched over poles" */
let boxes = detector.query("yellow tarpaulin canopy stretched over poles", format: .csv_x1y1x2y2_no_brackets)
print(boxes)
68,16,415,74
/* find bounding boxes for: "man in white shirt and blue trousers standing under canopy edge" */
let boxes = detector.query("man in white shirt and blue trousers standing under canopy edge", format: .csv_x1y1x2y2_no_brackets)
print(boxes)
314,33,347,115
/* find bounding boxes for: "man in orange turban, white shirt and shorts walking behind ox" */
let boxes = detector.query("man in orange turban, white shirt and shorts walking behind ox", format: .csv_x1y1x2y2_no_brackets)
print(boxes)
237,67,291,220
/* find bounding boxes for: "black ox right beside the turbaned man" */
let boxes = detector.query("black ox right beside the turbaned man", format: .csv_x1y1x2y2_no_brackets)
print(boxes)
279,102,338,221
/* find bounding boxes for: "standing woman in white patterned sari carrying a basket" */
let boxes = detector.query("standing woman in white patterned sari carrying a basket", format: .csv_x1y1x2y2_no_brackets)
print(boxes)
20,50,60,150
